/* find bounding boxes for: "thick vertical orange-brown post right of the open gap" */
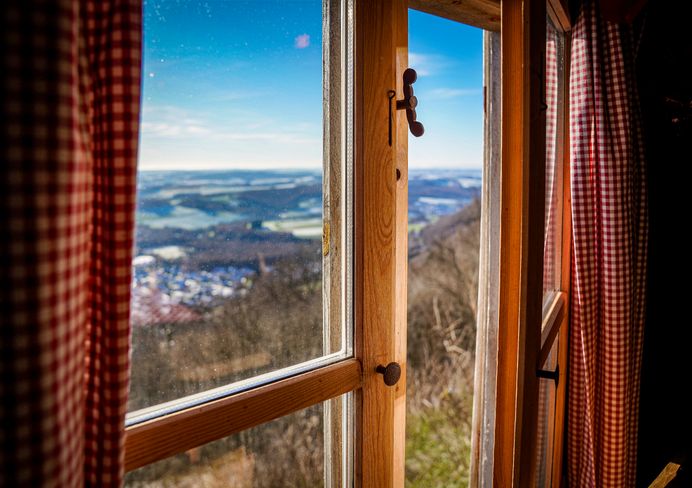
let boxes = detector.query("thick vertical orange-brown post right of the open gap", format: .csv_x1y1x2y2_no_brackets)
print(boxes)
494,0,546,487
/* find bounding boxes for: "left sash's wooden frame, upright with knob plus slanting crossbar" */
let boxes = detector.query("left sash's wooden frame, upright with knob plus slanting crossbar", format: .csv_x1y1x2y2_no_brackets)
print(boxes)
125,0,408,487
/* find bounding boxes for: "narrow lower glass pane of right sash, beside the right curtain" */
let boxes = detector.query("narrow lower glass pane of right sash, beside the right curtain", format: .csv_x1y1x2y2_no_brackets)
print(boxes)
536,338,564,488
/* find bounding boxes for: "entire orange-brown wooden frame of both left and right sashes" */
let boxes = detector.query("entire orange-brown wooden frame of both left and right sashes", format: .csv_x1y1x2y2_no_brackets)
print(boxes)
125,0,570,487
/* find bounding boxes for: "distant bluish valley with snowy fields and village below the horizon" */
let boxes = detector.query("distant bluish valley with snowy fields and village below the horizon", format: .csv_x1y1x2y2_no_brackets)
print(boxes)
128,170,481,326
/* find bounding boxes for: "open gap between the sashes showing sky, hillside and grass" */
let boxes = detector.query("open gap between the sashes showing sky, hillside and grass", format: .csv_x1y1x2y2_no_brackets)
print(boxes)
406,10,483,488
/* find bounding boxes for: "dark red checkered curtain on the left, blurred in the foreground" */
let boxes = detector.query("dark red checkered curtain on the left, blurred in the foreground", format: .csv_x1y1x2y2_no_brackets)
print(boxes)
0,0,141,487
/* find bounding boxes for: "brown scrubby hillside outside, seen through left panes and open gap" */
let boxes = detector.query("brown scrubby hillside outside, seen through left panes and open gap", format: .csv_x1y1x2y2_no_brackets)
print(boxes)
127,202,480,487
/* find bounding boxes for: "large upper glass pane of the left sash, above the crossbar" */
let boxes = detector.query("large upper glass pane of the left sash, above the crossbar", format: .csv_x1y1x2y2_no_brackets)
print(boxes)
129,0,351,411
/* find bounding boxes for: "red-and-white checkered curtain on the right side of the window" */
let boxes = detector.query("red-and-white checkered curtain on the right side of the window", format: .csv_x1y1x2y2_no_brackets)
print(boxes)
567,1,647,488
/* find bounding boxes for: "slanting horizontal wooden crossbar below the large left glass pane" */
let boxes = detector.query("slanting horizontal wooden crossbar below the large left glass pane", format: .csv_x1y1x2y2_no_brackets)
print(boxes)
125,359,361,471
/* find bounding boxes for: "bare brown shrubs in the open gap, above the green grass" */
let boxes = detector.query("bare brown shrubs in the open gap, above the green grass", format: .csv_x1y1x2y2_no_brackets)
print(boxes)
408,201,480,411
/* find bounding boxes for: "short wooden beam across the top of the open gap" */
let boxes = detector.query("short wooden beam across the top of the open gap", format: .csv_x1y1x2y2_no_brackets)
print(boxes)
408,0,500,32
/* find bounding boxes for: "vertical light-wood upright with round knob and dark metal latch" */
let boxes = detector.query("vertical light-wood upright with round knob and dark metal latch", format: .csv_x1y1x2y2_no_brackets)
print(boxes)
354,0,408,488
